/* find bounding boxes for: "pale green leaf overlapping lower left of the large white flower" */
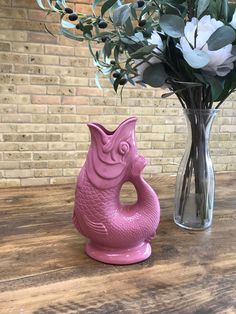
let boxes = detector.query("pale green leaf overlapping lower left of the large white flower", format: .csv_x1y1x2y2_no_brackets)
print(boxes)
183,49,210,69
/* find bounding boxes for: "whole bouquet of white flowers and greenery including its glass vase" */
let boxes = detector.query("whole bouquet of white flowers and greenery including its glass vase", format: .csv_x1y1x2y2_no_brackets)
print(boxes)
36,0,236,230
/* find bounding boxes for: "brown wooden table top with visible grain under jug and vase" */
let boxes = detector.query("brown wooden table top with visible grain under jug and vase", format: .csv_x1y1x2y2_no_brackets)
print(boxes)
0,173,236,314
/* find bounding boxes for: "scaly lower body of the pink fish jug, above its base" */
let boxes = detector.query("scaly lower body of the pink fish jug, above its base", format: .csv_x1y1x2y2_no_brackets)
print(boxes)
74,169,160,248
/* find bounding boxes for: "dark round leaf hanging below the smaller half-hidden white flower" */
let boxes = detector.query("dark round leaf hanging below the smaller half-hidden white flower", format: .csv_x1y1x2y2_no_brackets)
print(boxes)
143,63,168,87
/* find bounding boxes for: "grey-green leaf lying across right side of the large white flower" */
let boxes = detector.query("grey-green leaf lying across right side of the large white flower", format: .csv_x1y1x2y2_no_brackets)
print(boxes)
207,25,236,50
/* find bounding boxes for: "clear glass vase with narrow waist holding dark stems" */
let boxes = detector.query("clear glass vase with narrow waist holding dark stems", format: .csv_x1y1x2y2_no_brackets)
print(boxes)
174,109,219,230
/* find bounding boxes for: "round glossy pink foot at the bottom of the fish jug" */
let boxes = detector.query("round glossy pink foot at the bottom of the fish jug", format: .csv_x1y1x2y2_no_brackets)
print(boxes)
85,242,152,265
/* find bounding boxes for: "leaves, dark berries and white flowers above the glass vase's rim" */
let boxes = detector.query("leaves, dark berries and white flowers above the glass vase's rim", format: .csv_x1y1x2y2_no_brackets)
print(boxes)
36,0,236,109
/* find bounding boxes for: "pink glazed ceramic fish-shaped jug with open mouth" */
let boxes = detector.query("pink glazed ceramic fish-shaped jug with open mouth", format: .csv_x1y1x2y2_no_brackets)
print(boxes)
73,117,160,264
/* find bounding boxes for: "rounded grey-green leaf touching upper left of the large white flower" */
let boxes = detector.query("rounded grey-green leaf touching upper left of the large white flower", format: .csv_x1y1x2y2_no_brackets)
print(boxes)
160,14,185,38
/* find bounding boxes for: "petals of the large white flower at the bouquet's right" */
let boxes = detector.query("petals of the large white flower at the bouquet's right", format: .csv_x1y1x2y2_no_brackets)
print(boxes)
177,15,236,76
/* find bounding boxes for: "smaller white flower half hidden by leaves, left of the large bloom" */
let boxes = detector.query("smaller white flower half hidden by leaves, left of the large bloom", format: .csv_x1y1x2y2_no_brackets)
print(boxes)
133,31,164,82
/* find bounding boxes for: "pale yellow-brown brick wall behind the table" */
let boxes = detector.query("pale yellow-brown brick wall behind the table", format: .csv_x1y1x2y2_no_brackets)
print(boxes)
0,0,236,187
